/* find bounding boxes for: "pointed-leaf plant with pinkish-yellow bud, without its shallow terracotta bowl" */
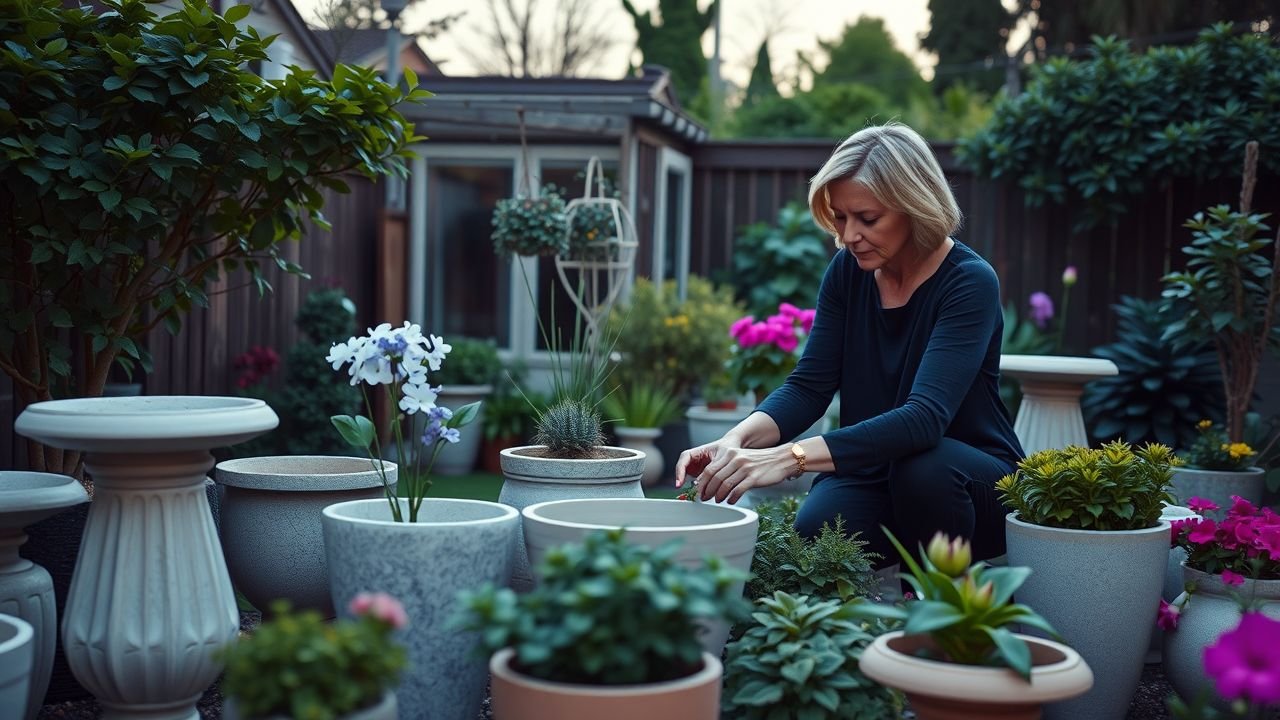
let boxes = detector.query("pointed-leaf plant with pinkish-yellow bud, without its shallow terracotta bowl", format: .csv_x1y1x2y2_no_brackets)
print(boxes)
854,529,1061,683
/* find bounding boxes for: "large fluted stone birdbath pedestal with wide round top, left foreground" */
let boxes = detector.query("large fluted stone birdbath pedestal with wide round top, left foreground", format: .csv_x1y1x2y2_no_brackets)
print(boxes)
15,396,279,720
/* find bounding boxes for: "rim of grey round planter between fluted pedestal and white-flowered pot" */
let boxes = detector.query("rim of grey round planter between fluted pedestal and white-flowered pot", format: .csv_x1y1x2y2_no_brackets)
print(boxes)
214,455,399,492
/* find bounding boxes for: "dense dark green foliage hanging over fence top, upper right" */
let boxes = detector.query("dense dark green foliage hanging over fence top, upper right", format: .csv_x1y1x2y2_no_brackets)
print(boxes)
957,24,1280,228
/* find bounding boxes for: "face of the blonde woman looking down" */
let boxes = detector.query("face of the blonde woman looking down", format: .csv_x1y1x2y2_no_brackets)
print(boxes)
828,179,915,270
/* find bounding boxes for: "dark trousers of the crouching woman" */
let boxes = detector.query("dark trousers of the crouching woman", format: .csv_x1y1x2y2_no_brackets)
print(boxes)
796,438,1012,569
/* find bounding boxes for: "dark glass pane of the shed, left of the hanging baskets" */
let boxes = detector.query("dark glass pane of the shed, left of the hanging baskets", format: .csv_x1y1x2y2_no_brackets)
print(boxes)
426,161,512,347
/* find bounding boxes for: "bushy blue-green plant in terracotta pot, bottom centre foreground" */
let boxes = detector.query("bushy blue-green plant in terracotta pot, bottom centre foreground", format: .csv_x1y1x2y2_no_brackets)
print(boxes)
457,530,748,720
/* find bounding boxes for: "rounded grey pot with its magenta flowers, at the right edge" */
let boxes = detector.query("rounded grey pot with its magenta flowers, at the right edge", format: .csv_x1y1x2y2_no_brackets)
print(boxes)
1157,497,1280,710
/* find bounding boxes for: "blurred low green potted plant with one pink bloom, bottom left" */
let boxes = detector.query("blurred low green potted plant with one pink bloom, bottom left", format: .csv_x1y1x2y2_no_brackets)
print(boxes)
221,593,407,720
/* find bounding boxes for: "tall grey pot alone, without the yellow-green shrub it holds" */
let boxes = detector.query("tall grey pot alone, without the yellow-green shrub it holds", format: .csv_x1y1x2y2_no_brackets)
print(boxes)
1005,512,1170,720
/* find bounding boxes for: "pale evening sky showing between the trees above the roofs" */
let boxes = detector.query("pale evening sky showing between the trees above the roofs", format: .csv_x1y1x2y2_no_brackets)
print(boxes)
294,0,933,87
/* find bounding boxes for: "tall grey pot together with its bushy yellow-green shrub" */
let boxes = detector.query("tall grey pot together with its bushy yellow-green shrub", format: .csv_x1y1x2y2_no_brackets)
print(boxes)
996,442,1179,719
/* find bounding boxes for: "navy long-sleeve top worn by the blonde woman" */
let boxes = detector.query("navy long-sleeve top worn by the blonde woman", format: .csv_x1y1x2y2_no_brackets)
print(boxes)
758,242,1023,479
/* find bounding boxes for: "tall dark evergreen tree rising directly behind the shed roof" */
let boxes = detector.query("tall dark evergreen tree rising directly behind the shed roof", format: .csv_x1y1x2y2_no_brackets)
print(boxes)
622,0,719,106
